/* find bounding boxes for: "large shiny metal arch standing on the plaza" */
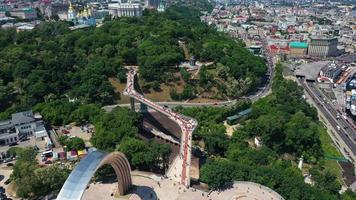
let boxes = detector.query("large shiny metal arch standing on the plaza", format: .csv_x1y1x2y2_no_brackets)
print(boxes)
57,151,132,200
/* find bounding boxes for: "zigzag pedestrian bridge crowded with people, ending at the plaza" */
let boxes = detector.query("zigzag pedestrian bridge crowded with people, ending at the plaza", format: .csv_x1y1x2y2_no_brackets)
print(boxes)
123,66,198,187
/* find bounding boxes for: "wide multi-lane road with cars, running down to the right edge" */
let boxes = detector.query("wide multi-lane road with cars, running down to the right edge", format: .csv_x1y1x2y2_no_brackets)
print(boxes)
299,79,356,163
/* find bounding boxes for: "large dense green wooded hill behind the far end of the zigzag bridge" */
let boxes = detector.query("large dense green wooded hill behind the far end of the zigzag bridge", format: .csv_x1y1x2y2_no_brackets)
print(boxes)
0,6,266,116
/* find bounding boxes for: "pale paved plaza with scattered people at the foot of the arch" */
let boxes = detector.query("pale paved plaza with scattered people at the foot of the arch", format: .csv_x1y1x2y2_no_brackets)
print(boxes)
83,175,283,200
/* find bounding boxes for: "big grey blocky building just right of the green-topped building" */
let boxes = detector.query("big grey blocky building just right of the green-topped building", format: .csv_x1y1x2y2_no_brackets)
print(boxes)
308,36,338,57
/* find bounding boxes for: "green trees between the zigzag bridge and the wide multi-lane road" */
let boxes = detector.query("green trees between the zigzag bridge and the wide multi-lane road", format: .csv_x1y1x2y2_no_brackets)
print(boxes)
184,65,354,200
